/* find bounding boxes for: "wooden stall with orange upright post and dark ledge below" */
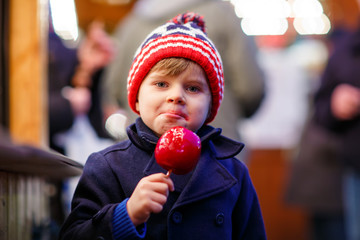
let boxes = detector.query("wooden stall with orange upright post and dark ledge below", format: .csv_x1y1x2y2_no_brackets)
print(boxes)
0,0,82,240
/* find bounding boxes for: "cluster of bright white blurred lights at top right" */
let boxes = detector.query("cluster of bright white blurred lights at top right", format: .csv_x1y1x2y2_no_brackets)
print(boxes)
226,0,331,35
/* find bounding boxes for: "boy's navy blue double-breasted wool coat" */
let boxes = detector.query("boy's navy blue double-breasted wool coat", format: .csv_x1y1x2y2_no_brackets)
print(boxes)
60,119,266,240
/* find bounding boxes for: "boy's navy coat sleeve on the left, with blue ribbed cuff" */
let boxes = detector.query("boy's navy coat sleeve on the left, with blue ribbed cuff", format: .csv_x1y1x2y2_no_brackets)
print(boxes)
59,153,143,240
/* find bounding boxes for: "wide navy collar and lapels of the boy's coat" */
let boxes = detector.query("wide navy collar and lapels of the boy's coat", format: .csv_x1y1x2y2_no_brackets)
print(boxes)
128,118,244,207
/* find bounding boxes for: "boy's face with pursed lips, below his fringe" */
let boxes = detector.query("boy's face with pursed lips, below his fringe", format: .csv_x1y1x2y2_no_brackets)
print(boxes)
136,63,211,136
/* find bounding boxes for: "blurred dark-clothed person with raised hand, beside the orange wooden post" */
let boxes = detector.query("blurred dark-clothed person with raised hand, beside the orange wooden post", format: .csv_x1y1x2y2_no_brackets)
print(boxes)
49,22,114,155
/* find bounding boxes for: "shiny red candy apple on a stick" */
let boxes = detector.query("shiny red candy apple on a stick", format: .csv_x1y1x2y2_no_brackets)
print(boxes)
155,127,201,174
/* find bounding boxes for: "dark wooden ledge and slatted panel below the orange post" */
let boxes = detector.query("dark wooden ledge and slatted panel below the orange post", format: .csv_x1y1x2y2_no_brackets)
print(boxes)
0,139,82,240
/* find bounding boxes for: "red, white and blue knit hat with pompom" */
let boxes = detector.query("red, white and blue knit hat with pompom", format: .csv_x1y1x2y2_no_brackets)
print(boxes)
127,12,224,123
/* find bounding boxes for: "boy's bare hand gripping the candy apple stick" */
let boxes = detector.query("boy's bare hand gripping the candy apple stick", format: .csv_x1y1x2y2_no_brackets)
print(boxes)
126,173,175,226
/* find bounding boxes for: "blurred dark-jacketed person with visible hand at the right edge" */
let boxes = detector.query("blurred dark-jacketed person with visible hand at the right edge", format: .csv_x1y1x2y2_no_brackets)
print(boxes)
315,15,360,240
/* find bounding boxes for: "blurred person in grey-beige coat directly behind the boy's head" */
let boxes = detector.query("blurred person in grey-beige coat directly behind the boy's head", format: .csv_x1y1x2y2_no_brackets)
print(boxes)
103,0,266,160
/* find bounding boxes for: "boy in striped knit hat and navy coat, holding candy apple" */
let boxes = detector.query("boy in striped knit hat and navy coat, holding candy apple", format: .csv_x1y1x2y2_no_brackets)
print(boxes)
60,13,266,239
